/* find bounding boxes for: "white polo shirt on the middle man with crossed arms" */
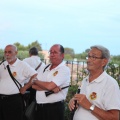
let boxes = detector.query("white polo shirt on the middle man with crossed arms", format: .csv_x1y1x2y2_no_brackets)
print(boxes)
36,62,70,103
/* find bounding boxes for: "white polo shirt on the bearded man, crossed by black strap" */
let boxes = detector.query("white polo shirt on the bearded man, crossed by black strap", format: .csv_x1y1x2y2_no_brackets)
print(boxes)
0,59,37,95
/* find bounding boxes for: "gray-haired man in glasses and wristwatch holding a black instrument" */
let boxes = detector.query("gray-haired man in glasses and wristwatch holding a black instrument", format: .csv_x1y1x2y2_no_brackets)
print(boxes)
69,45,120,120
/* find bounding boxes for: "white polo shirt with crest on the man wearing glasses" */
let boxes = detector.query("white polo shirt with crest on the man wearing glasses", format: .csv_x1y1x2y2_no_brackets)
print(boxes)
73,71,120,120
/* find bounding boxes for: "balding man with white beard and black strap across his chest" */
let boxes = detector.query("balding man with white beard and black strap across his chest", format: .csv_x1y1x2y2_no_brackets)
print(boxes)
0,45,37,120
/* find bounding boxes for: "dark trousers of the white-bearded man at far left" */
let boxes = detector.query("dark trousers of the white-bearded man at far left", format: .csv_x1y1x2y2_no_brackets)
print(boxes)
0,94,23,120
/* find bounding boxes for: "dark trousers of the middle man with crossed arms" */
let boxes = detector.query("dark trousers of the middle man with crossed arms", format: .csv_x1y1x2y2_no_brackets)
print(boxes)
35,101,65,120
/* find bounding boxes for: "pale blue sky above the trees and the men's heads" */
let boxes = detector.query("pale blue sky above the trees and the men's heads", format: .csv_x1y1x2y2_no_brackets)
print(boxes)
0,0,120,55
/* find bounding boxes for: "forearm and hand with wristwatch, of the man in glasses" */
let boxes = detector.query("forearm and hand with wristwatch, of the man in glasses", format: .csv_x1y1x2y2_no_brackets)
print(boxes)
74,94,119,120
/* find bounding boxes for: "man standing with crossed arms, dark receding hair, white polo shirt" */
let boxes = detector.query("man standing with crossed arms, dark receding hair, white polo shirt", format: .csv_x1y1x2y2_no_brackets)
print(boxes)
32,44,70,120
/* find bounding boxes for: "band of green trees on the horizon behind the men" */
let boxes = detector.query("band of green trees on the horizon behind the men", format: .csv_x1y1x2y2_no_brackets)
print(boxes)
0,40,120,64
